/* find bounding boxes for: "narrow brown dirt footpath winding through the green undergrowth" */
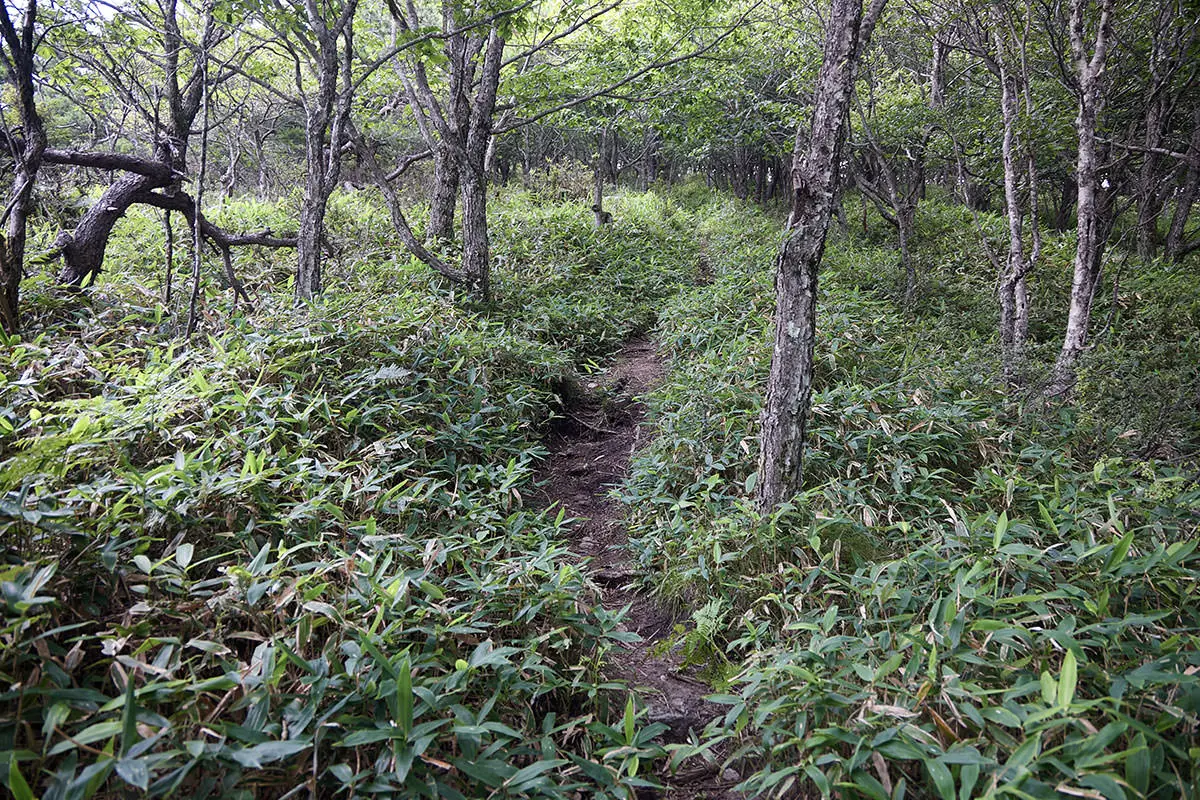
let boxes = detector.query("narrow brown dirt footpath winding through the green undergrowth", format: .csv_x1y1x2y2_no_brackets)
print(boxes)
541,338,740,800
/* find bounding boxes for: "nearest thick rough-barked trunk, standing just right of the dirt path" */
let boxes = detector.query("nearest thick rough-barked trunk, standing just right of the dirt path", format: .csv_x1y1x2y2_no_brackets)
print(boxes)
756,0,886,513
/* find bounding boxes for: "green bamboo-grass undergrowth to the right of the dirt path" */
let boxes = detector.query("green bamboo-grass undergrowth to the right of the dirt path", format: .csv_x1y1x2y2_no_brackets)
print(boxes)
622,185,1200,800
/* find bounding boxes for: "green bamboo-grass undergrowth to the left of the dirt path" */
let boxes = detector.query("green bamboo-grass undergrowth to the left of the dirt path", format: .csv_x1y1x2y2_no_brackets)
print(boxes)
0,190,690,798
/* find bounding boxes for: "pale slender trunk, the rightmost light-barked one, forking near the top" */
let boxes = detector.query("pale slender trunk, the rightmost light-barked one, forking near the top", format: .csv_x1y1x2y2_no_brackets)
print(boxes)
1046,0,1112,396
